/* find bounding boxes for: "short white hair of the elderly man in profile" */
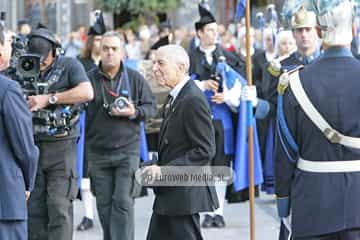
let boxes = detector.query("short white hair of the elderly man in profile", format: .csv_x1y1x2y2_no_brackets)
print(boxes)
158,44,190,73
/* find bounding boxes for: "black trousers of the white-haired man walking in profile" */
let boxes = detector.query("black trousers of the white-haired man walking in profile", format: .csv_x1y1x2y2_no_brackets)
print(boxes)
146,213,203,240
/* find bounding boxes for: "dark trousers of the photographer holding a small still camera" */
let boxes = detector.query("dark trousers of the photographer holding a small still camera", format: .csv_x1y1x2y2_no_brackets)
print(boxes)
89,153,140,240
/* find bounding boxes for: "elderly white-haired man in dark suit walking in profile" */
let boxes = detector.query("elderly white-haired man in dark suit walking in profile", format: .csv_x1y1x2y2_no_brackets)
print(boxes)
143,45,219,240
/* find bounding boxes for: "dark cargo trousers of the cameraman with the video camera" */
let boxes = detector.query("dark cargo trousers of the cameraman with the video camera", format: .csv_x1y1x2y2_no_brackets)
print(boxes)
28,139,78,240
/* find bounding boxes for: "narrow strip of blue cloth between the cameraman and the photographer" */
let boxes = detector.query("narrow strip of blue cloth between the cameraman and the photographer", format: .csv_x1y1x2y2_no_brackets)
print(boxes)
76,111,86,187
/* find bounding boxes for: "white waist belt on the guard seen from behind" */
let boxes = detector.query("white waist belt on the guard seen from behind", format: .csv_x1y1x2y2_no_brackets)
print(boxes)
297,158,360,173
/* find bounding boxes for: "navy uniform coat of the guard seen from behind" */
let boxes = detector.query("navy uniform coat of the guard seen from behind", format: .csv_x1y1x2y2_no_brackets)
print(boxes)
275,48,360,238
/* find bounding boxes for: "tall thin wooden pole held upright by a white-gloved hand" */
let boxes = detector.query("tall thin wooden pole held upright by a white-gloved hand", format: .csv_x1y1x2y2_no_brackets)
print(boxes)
245,0,255,240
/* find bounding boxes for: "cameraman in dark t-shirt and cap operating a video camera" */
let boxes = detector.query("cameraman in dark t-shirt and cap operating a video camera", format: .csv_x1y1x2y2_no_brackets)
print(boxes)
28,28,94,240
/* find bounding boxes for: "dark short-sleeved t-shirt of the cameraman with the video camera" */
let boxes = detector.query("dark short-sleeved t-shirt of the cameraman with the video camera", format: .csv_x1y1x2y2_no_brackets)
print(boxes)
35,57,89,141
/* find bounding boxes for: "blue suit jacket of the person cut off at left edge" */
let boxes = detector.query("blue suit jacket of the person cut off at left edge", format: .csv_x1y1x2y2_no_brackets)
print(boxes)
0,75,39,220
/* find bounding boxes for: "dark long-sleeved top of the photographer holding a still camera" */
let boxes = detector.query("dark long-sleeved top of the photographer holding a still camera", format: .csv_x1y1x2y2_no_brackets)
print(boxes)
86,66,156,154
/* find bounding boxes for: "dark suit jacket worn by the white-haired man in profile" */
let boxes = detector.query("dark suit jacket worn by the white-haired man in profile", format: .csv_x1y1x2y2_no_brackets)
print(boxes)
153,80,219,216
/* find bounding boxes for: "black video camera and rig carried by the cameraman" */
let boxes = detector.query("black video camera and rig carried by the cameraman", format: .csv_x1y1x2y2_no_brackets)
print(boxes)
4,30,82,136
